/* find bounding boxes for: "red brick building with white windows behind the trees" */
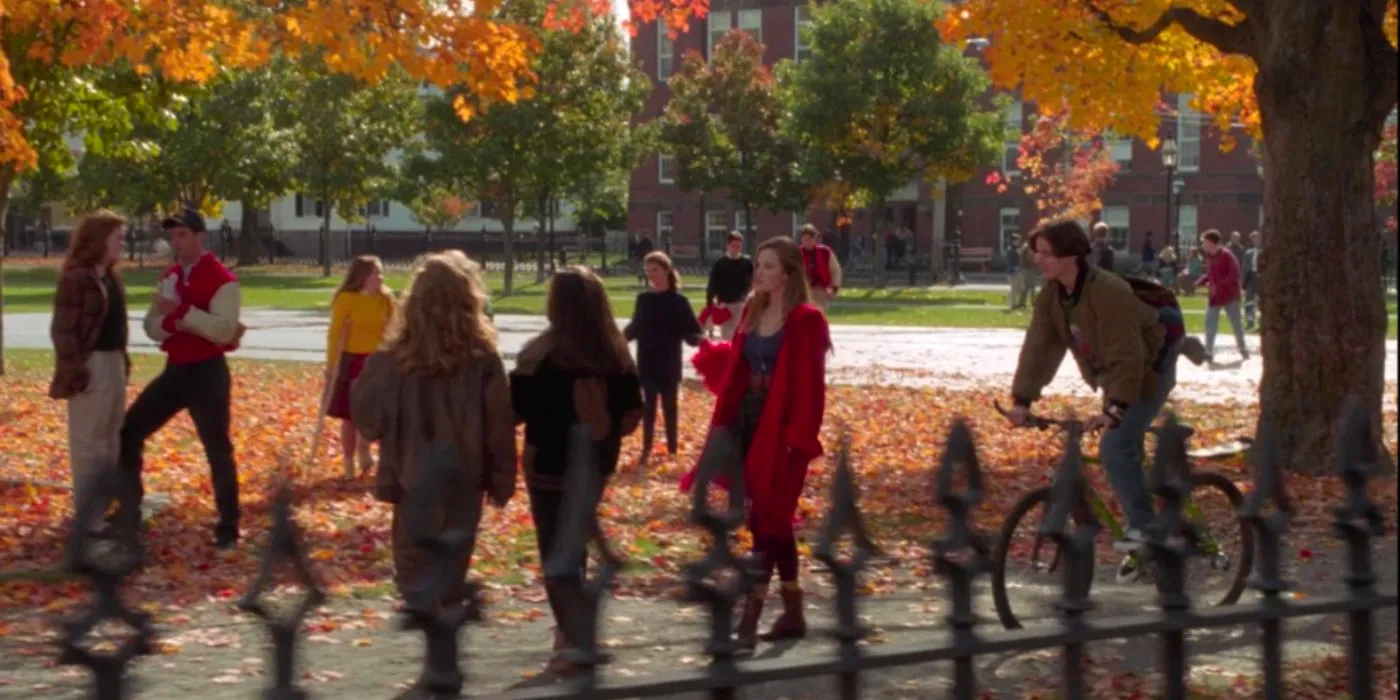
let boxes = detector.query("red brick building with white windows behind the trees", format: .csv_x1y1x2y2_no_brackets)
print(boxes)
627,0,1264,259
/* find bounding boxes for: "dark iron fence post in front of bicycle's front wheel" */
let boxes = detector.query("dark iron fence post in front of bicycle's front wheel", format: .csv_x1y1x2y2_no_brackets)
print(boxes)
1040,427,1103,700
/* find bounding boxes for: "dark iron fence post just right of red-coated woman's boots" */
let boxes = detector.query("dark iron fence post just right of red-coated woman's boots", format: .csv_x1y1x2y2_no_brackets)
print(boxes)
815,434,879,700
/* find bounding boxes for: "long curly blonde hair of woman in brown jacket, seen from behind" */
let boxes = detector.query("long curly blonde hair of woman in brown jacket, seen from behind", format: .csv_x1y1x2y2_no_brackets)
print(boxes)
385,251,496,375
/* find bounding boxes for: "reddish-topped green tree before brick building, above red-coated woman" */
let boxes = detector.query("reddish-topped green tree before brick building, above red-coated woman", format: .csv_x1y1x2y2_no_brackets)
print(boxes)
661,31,809,249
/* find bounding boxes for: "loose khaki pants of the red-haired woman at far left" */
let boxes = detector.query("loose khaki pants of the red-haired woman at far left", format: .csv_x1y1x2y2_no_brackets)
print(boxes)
69,350,126,526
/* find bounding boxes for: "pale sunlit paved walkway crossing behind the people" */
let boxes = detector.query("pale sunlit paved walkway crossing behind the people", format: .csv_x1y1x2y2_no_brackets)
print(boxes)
4,309,1397,403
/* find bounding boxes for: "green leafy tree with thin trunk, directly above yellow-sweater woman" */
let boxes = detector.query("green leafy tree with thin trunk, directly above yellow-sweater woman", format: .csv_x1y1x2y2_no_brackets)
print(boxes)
284,60,421,277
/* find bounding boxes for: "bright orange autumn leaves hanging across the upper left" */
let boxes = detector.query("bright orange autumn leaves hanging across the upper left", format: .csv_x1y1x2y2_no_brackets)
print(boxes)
0,0,708,172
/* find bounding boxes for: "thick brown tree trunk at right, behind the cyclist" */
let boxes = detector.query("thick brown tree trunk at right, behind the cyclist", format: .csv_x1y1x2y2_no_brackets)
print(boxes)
1254,6,1394,475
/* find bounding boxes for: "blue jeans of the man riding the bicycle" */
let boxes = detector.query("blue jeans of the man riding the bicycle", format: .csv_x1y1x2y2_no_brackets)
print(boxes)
1099,342,1180,531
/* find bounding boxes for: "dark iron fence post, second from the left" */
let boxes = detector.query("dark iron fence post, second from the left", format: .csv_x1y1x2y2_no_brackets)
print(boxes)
238,482,326,700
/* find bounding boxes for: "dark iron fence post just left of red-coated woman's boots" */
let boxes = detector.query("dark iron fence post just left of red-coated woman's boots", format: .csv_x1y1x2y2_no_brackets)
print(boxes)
685,427,760,700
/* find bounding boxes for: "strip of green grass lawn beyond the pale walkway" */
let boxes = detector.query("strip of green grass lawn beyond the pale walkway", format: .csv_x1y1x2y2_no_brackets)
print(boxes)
4,265,1397,337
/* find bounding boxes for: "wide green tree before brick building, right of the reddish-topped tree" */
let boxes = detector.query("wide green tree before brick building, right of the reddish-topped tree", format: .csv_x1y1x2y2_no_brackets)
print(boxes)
778,0,1005,287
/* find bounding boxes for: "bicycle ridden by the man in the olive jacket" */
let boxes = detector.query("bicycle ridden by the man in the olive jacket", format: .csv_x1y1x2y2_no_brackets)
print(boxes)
991,405,1254,630
